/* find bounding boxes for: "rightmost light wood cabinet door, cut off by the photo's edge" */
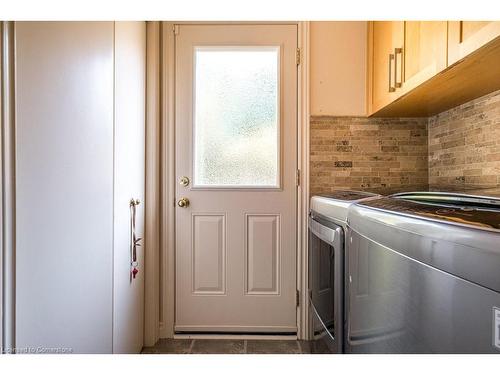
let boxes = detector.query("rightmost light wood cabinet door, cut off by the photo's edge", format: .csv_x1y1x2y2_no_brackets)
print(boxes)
448,21,500,66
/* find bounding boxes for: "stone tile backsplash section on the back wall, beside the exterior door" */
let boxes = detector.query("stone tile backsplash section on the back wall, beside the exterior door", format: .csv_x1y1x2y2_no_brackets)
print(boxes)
310,116,428,195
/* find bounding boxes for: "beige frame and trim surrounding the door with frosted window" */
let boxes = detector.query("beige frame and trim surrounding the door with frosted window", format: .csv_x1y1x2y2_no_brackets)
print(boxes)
144,21,310,346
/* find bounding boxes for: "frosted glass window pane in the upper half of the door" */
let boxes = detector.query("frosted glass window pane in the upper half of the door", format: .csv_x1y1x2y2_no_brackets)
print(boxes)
193,47,280,187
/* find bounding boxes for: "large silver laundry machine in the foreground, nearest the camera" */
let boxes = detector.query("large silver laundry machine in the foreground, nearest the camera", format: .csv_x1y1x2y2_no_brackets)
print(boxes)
346,192,500,353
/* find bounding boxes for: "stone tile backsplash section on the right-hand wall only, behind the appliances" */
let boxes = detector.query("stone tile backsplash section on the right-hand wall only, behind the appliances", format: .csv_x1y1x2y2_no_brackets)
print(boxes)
429,91,500,189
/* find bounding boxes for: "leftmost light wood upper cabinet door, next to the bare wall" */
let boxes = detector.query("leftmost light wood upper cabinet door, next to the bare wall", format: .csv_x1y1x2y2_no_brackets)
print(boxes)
371,21,404,112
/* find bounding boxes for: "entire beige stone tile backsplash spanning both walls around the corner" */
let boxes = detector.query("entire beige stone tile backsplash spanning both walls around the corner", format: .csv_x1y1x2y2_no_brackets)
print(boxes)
310,91,500,195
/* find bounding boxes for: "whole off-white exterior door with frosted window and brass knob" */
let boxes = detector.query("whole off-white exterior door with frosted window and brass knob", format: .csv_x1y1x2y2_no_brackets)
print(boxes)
175,24,297,332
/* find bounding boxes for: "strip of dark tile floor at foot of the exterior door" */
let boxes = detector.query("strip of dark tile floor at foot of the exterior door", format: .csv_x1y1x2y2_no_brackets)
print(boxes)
142,339,320,354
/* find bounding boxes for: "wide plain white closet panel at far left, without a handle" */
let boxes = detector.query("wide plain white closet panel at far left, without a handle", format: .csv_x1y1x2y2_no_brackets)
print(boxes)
16,22,113,353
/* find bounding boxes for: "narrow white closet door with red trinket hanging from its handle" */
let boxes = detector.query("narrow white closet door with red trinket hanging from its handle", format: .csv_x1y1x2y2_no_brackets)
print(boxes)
113,22,146,353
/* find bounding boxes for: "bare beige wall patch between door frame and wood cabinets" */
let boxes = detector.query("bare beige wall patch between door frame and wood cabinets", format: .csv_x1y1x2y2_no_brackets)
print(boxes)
310,21,368,116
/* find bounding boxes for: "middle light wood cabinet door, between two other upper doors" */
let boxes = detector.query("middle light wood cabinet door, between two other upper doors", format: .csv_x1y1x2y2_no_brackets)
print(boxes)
402,21,447,92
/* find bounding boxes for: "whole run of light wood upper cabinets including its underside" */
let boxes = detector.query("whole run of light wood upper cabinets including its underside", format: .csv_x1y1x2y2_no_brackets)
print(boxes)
367,21,500,116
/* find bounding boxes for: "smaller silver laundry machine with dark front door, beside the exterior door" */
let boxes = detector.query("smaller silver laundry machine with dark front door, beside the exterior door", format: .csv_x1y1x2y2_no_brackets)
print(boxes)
309,190,376,353
